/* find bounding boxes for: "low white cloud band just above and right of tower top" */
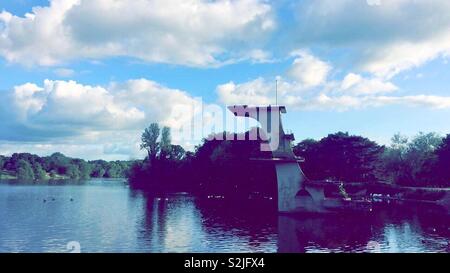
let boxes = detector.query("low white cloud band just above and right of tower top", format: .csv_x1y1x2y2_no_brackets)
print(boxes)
216,51,450,111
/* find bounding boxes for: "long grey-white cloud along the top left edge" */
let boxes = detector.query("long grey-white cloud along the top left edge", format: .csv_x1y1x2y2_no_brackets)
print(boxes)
0,0,275,66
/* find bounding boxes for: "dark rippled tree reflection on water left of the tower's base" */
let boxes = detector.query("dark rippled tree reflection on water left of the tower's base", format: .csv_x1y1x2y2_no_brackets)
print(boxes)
140,192,276,252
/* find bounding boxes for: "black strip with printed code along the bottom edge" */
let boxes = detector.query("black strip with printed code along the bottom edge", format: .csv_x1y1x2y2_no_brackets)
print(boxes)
0,253,444,272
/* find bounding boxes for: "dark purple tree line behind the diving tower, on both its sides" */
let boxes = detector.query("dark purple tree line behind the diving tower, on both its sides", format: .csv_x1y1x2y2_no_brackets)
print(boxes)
129,124,450,196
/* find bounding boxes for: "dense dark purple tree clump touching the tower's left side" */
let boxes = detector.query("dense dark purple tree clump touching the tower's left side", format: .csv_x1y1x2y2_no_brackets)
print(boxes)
190,133,276,198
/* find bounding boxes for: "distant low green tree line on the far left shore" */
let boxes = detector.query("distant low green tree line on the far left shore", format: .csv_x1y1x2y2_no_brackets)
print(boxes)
0,153,132,180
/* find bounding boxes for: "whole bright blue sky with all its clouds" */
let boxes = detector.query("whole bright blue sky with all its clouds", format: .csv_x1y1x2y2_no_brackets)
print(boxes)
0,0,450,160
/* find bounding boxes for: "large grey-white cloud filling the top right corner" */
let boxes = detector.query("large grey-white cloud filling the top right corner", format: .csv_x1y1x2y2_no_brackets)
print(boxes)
290,0,450,77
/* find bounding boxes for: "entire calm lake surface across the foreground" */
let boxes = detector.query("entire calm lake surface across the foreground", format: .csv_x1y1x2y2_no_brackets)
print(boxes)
0,180,450,252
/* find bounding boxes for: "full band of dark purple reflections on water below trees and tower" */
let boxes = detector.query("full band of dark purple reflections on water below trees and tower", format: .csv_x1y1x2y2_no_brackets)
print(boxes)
132,190,450,252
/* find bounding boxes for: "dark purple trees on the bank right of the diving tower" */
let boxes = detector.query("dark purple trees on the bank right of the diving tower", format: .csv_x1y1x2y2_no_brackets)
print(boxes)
294,132,450,187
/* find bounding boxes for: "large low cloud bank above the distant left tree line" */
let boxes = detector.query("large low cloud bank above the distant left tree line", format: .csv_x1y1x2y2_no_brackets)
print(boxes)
0,79,200,159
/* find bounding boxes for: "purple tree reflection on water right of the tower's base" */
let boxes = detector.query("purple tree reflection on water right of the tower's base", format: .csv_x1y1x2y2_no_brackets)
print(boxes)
278,204,450,252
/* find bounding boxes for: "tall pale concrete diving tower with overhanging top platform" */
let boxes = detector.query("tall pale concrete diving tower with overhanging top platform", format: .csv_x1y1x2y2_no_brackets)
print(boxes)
228,105,306,212
